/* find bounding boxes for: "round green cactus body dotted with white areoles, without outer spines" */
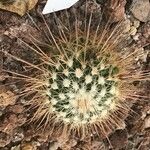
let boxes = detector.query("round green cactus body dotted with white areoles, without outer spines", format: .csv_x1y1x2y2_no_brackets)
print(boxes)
47,43,118,123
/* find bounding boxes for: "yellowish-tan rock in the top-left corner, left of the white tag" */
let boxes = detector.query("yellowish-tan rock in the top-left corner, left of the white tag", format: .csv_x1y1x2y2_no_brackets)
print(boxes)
0,0,38,16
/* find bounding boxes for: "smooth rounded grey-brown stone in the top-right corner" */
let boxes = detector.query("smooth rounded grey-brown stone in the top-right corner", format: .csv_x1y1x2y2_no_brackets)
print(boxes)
130,0,150,22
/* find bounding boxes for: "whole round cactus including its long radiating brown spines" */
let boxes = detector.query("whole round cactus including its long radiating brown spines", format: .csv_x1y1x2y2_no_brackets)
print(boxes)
2,0,150,137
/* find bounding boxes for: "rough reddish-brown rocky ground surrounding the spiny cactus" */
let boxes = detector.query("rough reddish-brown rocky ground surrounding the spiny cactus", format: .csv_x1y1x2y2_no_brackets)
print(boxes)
0,0,150,150
